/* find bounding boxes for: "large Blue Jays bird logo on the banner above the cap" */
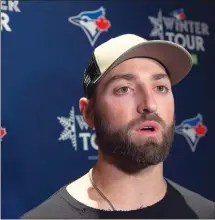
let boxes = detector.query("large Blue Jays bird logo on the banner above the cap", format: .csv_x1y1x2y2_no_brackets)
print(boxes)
69,7,111,46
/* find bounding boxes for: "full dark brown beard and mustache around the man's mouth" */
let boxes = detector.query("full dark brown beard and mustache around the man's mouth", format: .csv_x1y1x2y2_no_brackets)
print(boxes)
94,110,175,173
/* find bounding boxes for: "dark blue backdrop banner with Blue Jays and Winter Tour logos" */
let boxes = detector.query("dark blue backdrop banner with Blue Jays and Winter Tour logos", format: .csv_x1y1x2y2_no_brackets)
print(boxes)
1,0,215,218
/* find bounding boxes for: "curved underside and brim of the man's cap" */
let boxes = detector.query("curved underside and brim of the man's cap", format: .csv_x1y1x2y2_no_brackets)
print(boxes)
96,40,192,85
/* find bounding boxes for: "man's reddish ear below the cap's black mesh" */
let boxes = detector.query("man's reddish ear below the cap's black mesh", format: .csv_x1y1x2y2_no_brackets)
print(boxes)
79,97,94,128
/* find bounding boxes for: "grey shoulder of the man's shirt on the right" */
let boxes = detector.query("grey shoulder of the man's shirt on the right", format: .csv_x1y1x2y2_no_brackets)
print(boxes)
166,179,215,219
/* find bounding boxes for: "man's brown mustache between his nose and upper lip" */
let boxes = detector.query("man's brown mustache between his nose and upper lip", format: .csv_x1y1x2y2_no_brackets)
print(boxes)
126,113,166,130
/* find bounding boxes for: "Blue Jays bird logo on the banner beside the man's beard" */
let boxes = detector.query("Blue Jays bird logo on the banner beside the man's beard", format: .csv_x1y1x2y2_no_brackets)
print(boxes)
175,114,207,152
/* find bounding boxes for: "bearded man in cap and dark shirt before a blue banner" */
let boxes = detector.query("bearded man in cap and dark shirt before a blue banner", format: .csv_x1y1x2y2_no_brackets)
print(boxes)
22,34,215,219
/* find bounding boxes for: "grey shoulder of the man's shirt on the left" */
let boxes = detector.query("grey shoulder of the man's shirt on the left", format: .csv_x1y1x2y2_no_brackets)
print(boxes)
20,186,78,219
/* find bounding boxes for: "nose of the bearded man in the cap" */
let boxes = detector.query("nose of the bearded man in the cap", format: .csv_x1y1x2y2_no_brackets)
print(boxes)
137,91,157,114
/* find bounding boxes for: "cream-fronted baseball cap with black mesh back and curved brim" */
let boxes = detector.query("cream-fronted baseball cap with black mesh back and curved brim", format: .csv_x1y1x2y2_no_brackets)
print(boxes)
83,34,192,98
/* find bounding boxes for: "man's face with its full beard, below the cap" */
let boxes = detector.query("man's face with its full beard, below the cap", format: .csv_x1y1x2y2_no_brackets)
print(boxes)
90,58,175,172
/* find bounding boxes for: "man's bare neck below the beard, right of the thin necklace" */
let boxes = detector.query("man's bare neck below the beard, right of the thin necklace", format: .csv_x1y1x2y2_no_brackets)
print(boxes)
92,154,166,210
